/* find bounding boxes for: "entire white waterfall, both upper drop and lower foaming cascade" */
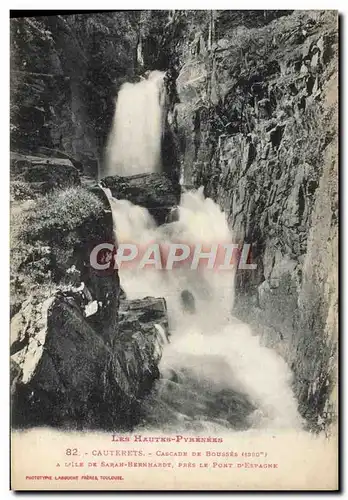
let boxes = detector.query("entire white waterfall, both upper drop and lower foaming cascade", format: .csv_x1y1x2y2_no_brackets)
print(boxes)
103,72,301,432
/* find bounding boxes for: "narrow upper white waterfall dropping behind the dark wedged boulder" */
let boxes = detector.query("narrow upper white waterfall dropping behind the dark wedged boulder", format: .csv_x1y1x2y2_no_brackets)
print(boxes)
106,71,166,176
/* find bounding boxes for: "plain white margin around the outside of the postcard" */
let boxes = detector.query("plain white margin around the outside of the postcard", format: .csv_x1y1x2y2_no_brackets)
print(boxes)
0,4,348,498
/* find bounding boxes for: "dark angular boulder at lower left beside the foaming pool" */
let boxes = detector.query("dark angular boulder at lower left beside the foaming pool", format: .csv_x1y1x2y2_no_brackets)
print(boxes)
11,292,167,429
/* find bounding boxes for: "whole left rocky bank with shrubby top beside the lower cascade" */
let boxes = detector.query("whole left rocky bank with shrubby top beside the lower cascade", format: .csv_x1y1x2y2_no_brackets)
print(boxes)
11,183,168,429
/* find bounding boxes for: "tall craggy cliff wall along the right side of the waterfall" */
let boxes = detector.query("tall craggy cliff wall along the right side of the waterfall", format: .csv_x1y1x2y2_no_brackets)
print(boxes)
176,11,338,428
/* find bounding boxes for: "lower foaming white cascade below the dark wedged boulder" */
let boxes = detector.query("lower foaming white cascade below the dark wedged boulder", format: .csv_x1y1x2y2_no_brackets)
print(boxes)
106,189,301,430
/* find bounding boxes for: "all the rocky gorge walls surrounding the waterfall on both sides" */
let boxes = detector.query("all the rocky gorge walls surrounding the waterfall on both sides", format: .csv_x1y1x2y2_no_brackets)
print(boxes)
11,10,338,430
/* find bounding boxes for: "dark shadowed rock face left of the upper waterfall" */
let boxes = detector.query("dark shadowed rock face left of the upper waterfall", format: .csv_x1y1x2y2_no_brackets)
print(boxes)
10,12,139,164
